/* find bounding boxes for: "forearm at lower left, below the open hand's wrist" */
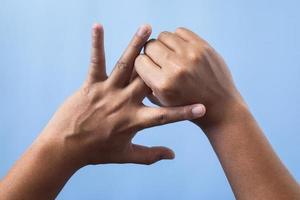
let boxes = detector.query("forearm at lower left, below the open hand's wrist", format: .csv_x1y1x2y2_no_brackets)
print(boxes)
0,134,79,200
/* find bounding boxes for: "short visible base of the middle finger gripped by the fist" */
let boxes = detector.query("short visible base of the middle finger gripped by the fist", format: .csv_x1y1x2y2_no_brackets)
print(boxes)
125,76,151,102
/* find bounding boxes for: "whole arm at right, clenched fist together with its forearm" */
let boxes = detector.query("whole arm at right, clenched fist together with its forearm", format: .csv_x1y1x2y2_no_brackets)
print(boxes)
135,28,300,200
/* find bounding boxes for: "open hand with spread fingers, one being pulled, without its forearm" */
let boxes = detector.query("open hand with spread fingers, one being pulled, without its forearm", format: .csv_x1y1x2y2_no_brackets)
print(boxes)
44,25,205,165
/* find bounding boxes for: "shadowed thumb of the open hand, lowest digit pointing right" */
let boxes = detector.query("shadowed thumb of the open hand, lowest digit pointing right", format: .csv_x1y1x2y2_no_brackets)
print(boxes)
128,144,175,165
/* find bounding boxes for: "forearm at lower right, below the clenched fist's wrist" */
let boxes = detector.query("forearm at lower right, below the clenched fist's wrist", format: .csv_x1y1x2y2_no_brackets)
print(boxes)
199,104,300,199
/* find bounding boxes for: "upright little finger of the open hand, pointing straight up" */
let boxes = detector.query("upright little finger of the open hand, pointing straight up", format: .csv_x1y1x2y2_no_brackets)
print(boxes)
88,24,107,83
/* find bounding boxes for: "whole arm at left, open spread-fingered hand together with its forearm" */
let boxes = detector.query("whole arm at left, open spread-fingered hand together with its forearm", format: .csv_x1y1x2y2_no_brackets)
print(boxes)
0,24,205,200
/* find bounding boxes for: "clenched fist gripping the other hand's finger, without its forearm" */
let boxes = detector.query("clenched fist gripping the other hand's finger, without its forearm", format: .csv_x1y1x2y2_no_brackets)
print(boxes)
135,28,243,127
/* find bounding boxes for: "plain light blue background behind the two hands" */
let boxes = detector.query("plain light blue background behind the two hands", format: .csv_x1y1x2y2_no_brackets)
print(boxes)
0,0,300,200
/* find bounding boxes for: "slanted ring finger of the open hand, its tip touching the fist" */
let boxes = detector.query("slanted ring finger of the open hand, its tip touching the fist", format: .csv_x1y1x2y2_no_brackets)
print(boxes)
110,25,151,87
